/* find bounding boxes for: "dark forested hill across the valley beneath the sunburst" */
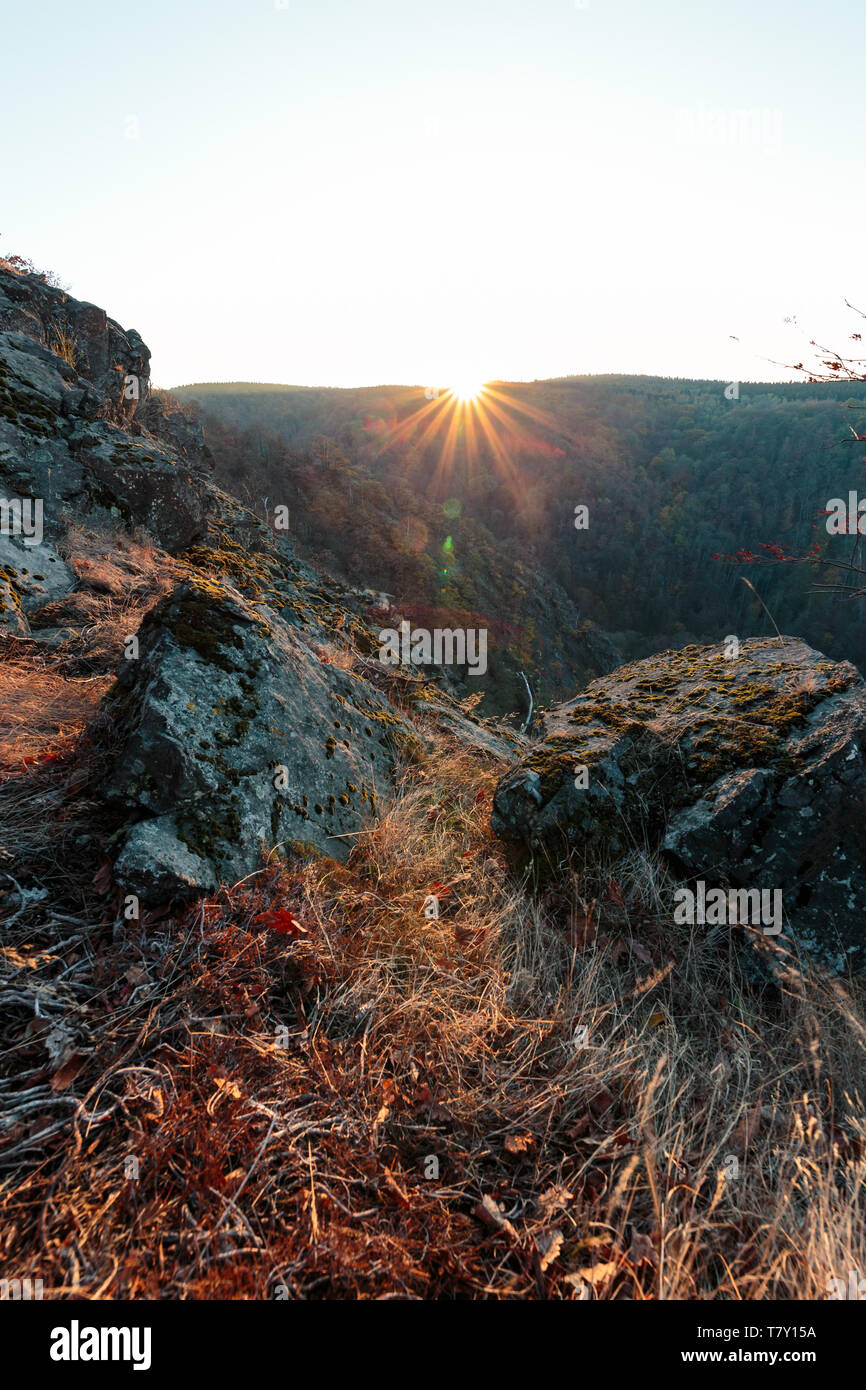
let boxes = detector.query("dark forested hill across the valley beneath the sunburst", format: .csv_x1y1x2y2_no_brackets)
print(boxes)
174,377,866,696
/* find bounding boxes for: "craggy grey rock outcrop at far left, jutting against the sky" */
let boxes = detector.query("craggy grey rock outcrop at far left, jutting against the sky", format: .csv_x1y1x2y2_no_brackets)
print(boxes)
0,264,210,630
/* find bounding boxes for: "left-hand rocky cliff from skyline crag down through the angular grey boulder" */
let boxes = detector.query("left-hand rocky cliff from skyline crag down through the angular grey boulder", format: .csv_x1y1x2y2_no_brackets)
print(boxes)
0,267,500,902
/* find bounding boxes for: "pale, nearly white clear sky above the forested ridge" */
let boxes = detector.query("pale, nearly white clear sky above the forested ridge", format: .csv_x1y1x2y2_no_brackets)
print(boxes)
0,0,866,386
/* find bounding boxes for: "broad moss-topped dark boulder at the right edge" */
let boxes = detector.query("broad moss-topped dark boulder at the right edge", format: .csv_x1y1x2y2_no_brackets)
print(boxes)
493,638,866,969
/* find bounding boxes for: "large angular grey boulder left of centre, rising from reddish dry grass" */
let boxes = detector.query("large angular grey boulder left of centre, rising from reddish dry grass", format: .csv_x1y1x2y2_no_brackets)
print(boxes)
106,578,414,901
